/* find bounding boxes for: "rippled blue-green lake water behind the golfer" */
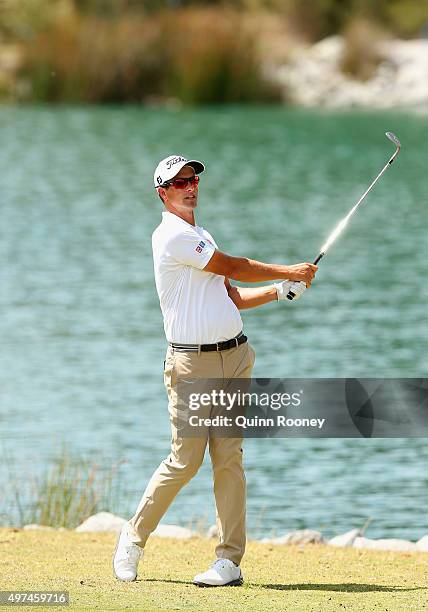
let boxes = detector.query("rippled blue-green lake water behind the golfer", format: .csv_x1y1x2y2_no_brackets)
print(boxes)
0,107,428,539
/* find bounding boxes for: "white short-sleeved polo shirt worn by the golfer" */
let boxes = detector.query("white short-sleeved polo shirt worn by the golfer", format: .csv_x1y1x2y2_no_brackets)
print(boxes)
152,212,243,344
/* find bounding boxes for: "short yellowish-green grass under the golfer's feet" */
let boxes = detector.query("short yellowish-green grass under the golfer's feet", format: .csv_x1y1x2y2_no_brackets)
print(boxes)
0,528,428,612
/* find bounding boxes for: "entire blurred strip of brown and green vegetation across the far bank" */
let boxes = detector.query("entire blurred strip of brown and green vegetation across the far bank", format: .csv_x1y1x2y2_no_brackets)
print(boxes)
0,0,428,107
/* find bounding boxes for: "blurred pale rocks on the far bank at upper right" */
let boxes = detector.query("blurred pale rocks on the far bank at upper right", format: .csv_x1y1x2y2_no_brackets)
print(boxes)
268,36,428,110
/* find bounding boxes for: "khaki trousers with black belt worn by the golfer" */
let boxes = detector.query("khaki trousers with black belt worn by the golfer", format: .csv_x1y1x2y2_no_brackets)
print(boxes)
128,342,255,565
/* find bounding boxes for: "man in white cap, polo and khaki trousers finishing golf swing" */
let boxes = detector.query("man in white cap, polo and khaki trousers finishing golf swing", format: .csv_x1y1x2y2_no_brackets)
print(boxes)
113,155,317,586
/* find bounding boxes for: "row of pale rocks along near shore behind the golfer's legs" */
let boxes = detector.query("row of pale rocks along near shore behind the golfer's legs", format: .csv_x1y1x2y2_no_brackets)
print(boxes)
17,512,428,553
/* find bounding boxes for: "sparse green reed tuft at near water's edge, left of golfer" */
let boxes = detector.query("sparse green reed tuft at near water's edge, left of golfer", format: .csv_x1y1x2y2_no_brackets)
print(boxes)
3,447,128,528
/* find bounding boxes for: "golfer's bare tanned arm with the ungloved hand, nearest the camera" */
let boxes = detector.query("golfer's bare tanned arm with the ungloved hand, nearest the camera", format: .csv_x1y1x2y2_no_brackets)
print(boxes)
204,250,318,289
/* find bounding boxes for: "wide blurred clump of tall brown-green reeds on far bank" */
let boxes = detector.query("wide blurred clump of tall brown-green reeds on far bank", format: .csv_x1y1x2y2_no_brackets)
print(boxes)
23,8,277,104
